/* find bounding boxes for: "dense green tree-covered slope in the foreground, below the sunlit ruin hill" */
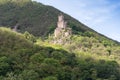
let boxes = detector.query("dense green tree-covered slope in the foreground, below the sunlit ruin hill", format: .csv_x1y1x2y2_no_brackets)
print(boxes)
0,28,120,80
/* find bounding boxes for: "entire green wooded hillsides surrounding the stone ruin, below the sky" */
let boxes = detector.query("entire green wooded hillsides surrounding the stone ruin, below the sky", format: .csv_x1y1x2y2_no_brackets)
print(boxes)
0,0,120,80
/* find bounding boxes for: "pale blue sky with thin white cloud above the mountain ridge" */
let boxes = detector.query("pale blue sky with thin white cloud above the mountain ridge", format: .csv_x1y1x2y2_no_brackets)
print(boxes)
33,0,120,42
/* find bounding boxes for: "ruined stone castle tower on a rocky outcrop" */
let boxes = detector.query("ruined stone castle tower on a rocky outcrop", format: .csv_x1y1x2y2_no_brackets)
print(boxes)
54,14,72,43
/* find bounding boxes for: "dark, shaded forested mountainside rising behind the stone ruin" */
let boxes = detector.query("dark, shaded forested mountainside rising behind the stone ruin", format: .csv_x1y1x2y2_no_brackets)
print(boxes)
0,0,98,36
